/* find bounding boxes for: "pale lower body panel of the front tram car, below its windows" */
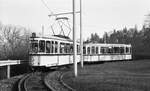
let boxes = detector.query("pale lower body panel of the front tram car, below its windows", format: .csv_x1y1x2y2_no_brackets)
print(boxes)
30,55,80,67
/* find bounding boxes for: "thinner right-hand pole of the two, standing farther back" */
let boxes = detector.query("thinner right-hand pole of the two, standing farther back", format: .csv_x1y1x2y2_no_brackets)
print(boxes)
80,0,83,68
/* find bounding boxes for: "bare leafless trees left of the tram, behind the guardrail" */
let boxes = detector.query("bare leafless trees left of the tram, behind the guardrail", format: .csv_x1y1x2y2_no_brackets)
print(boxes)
0,24,29,59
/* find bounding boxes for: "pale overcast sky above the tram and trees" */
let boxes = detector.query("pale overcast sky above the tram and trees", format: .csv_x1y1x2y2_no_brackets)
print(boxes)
0,0,150,39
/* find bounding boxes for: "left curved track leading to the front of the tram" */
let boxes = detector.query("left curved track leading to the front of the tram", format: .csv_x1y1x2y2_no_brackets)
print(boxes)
18,72,51,91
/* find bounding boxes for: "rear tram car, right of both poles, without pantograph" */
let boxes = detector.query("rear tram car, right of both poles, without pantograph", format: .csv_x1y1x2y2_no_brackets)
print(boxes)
83,43,132,62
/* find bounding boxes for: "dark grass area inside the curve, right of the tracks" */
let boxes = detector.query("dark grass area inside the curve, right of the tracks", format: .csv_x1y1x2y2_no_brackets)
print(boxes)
63,60,150,91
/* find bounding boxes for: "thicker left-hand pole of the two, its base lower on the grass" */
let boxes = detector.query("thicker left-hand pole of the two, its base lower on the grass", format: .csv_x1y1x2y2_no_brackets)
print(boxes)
72,0,77,77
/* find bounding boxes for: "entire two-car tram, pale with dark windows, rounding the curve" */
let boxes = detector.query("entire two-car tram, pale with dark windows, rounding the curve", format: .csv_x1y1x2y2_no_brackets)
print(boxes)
29,34,132,68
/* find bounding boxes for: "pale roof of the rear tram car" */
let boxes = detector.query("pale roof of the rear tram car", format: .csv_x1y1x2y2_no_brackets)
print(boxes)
84,43,131,47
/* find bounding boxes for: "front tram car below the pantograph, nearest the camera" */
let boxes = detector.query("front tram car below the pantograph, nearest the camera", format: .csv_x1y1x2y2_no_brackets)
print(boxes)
29,36,80,68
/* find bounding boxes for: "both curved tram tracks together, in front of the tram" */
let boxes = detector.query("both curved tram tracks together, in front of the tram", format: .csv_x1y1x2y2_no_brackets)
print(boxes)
18,67,72,91
